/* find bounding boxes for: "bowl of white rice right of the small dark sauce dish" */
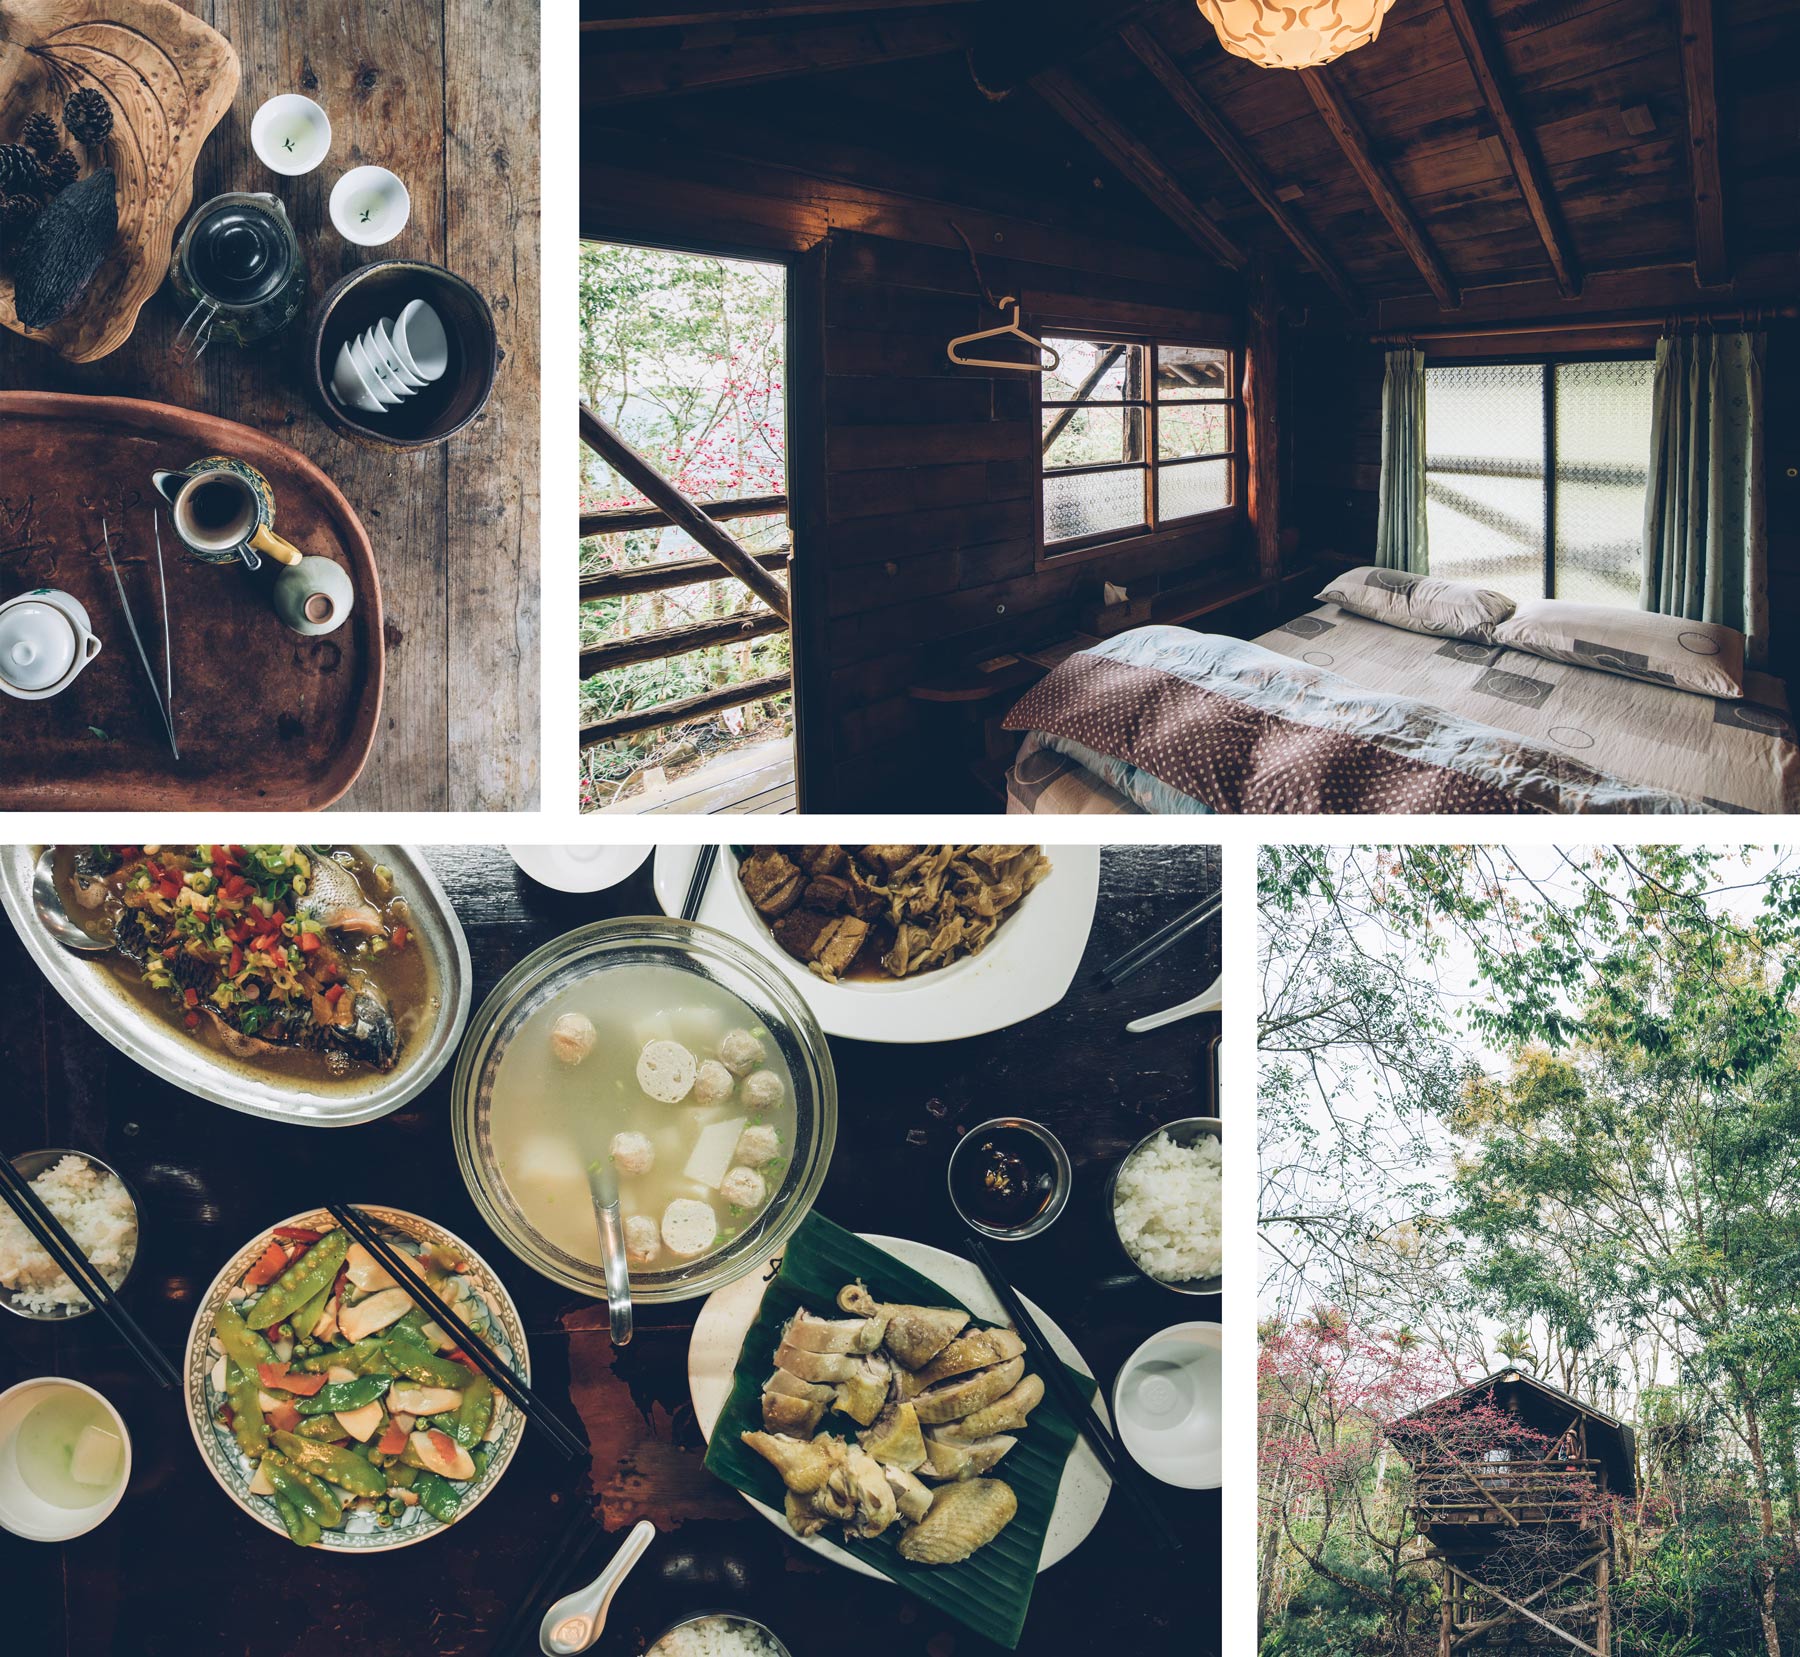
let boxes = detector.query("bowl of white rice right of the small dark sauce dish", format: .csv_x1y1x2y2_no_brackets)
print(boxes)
1107,1115,1224,1295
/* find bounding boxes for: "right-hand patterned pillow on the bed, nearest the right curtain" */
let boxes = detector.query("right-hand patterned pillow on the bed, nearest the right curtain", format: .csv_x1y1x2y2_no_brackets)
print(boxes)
1494,599,1744,700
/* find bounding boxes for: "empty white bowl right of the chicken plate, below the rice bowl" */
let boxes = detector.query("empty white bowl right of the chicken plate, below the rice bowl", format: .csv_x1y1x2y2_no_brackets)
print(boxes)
1112,1324,1224,1490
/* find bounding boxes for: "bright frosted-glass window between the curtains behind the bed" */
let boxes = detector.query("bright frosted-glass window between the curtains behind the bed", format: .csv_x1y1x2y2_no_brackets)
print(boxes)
1426,358,1654,608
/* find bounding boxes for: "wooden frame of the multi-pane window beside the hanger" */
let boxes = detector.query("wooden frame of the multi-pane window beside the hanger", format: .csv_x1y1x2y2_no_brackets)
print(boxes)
1033,326,1247,569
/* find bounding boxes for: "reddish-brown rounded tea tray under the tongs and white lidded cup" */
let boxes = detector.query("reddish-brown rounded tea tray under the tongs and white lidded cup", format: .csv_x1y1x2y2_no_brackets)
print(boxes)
0,390,383,811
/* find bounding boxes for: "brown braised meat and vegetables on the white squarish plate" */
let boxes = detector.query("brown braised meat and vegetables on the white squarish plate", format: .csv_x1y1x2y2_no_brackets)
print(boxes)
738,846,1051,982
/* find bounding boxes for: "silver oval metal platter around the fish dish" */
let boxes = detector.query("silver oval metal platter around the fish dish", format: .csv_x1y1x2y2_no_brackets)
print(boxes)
0,846,473,1128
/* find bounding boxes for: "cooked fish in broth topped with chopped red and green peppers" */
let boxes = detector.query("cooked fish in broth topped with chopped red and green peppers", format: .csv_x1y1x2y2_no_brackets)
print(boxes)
56,846,434,1083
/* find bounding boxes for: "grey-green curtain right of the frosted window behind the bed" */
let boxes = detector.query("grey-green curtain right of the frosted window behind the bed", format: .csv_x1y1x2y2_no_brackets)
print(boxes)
1640,329,1769,667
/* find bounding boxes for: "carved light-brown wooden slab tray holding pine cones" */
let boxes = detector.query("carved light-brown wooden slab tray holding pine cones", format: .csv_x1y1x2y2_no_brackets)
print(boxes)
0,0,238,362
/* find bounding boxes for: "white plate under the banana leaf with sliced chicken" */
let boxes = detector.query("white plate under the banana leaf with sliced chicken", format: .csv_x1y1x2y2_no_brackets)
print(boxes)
688,1231,1112,1581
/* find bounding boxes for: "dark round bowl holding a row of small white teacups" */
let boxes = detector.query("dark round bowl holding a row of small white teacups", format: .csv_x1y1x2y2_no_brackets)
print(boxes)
306,259,500,450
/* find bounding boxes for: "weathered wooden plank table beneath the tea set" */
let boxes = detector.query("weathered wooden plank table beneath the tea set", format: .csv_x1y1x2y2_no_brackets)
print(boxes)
0,0,540,811
